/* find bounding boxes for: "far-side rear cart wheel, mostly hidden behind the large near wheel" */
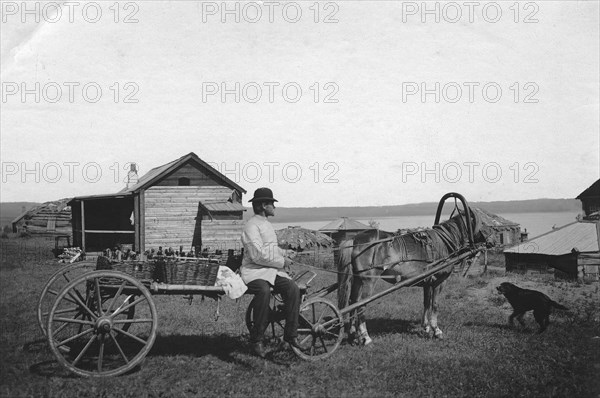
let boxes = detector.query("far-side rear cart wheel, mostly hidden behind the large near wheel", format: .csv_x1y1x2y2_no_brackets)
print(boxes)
37,261,96,336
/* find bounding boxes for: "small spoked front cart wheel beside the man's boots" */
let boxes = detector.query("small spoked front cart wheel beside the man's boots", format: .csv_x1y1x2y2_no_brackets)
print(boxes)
292,297,344,361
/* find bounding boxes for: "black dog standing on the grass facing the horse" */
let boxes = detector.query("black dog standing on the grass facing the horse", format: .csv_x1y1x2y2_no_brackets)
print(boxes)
496,282,568,333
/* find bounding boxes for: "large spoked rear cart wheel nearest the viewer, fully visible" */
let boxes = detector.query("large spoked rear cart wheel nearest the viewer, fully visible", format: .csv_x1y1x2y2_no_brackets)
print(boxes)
47,270,158,377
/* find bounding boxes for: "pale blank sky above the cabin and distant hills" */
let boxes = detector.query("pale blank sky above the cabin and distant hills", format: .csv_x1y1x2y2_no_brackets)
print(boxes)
0,1,600,207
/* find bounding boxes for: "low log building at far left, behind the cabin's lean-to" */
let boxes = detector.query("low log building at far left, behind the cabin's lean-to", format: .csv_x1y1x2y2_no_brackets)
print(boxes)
12,199,72,236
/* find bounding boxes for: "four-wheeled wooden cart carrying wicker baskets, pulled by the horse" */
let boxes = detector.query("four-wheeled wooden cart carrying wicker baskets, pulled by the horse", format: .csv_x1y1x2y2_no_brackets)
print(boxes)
38,255,343,377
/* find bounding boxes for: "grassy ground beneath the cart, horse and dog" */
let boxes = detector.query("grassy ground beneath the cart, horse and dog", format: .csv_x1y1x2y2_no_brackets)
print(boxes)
0,239,600,397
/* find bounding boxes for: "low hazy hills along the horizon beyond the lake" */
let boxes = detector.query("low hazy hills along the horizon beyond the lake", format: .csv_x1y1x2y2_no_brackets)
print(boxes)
0,199,581,226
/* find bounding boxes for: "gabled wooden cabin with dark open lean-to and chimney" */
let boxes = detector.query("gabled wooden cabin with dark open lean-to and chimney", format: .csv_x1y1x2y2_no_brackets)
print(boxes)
69,152,246,253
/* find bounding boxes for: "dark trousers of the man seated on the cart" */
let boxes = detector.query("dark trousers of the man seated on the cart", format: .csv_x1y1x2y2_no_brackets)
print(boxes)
246,275,300,343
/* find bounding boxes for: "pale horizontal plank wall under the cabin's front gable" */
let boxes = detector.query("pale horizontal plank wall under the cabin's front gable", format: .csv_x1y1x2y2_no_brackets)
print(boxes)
144,186,243,250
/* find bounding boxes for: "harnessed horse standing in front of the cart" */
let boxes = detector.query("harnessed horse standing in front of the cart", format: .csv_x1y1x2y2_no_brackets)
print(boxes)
338,210,493,345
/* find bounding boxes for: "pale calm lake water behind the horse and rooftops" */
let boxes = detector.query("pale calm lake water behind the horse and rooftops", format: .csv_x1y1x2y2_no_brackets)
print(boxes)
271,212,578,239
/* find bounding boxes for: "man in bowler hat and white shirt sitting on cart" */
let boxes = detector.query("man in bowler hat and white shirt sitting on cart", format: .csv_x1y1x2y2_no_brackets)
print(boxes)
240,188,300,358
